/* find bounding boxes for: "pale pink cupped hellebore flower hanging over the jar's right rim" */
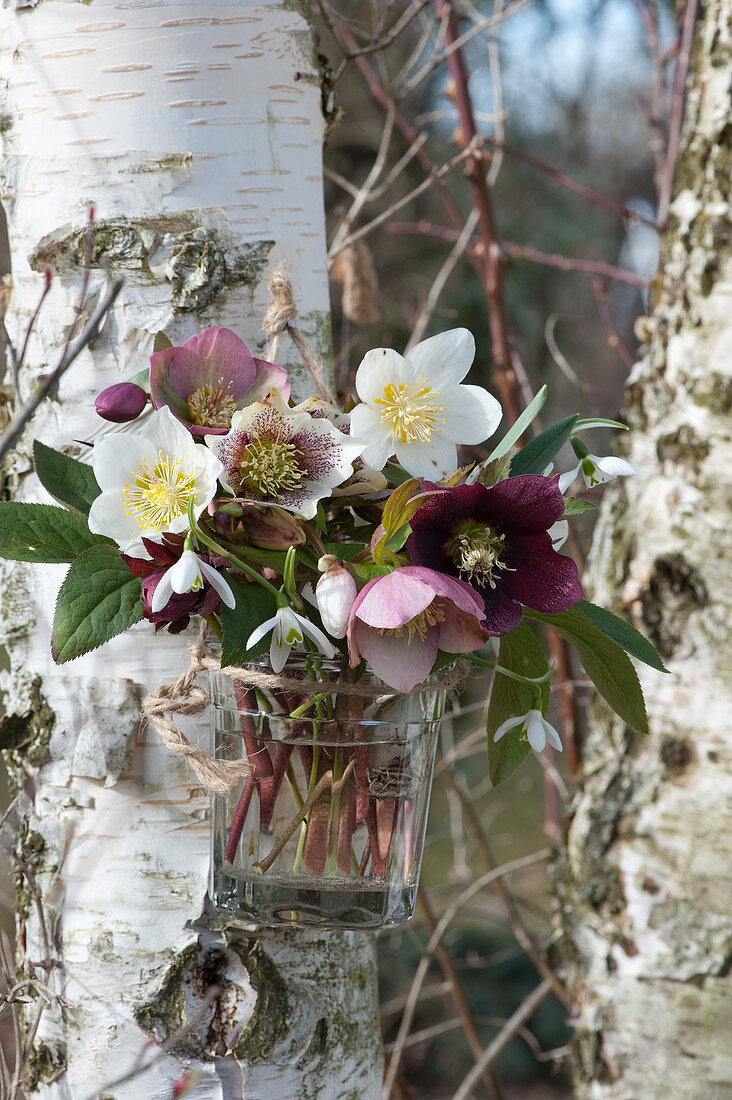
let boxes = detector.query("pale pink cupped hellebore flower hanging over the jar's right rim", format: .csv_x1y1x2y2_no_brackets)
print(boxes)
348,565,489,691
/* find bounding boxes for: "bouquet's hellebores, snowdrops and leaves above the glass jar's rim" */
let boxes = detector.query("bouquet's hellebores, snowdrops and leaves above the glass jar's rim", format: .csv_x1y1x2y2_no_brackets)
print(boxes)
0,319,663,782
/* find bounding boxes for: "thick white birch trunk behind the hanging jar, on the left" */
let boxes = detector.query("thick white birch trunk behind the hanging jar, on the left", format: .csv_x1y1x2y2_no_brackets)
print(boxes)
0,0,382,1100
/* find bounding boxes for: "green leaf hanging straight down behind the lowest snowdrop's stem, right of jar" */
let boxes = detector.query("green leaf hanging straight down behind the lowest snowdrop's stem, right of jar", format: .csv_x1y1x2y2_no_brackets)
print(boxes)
487,623,549,787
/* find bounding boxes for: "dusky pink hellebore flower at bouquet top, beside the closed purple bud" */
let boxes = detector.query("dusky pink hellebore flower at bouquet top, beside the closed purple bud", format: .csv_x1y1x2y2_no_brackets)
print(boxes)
150,327,289,439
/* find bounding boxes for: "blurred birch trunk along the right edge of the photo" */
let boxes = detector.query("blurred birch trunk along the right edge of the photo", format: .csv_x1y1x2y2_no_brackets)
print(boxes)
560,0,732,1100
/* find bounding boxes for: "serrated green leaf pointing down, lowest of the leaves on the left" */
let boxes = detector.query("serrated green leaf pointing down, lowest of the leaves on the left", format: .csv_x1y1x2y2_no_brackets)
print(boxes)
51,546,145,664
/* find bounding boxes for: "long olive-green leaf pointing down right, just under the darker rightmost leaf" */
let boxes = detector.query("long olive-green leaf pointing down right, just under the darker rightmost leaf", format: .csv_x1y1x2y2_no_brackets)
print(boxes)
524,605,648,734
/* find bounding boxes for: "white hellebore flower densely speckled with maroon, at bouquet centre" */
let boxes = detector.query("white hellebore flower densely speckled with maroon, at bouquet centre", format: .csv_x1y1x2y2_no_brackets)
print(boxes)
206,389,365,519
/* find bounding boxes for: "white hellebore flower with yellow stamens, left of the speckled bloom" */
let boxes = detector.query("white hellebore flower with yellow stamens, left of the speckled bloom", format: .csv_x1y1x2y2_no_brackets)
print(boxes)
89,406,223,558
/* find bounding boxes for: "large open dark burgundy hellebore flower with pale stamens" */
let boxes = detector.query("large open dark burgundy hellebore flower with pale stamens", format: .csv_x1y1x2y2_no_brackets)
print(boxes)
406,474,583,635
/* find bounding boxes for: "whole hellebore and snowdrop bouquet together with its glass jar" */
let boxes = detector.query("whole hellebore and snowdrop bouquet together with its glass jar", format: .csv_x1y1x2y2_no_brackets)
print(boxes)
0,314,663,927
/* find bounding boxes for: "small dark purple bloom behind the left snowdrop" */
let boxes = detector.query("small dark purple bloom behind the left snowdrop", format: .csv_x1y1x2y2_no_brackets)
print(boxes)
122,535,229,634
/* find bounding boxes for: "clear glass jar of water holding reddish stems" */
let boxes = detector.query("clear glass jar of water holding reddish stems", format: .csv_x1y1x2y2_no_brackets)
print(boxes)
209,656,445,928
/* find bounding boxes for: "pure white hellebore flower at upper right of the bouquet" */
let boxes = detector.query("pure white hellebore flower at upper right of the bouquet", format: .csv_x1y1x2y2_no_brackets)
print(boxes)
351,329,503,481
